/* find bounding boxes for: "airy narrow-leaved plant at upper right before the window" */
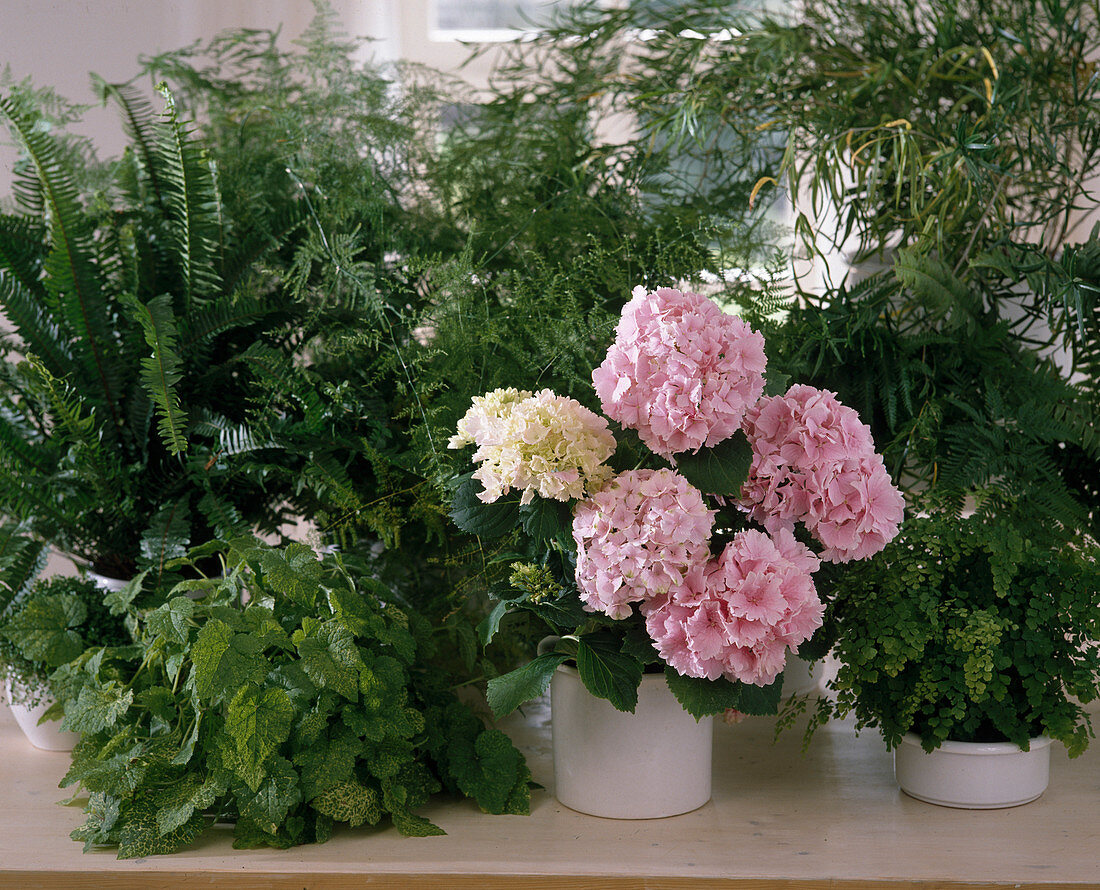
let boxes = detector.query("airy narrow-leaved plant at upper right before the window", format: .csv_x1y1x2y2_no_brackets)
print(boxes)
589,0,1100,261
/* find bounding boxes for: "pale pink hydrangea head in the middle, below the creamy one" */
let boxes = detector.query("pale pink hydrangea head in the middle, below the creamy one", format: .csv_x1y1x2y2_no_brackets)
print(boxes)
573,470,714,618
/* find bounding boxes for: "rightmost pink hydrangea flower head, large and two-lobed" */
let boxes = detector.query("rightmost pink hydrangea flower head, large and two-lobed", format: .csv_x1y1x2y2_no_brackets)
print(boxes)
741,384,904,562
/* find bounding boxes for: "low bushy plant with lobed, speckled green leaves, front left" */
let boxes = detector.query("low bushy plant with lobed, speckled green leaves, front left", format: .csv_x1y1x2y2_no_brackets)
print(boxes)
55,538,529,858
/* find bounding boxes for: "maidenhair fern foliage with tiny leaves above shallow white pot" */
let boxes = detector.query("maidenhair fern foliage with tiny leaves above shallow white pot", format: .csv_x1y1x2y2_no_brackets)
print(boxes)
811,503,1100,757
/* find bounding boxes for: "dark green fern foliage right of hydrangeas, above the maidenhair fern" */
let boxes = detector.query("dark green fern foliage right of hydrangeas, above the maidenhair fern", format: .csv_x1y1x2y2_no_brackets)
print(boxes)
769,252,1100,527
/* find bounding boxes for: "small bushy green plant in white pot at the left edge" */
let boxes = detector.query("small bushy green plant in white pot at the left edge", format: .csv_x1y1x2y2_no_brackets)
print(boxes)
0,571,130,706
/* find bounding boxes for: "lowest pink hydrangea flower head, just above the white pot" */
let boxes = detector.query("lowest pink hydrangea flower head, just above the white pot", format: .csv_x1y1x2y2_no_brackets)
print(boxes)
641,530,824,685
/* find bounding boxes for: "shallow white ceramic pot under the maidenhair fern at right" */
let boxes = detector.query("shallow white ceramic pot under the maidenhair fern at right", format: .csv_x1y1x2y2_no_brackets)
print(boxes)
894,733,1051,810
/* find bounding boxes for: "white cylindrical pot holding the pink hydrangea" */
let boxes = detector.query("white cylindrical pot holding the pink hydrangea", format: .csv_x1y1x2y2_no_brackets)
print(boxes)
550,664,714,818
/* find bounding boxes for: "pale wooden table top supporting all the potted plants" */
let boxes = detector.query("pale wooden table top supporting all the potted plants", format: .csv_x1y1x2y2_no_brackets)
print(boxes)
0,702,1100,890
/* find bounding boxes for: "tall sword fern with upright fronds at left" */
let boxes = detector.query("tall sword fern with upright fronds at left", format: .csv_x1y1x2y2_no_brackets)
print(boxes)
0,86,338,578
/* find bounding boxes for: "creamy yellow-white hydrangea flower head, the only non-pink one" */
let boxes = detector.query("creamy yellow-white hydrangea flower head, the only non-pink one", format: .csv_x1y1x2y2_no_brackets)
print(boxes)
448,389,615,504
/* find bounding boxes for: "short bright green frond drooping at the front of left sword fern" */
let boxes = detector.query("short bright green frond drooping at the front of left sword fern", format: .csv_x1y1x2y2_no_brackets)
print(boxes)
122,294,187,454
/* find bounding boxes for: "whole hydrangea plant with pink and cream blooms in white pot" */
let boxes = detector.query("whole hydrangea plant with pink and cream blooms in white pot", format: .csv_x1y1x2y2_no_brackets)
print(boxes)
450,287,903,816
